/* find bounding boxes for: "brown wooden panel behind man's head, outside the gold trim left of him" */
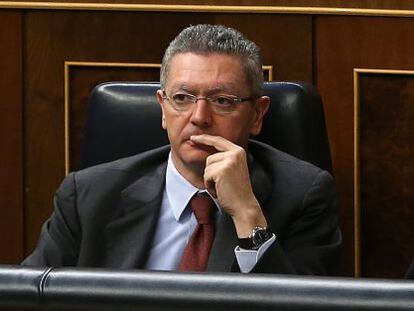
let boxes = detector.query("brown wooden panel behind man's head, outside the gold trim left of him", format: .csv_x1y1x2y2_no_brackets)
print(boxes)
24,11,312,253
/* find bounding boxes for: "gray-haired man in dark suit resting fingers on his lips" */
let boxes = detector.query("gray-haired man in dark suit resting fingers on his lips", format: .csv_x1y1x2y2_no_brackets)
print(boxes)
24,25,341,274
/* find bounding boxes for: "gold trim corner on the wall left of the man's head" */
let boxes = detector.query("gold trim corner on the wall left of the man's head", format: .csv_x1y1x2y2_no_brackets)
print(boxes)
64,61,161,175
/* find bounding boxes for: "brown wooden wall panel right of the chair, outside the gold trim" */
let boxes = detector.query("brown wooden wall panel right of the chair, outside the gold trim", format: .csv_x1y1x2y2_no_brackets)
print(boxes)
315,16,414,276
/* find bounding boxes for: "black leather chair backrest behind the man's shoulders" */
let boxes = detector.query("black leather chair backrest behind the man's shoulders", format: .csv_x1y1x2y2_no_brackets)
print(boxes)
80,82,332,172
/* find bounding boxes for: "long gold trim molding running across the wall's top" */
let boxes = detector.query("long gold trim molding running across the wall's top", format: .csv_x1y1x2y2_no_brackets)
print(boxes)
0,1,414,17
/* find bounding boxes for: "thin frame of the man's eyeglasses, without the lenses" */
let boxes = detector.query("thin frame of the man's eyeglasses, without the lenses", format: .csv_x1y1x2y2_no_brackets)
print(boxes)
161,89,261,114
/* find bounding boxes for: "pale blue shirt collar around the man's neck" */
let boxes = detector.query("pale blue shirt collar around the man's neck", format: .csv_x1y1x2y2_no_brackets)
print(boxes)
165,153,221,221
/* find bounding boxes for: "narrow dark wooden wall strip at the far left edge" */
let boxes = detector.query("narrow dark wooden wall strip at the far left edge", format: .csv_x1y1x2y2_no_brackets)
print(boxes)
0,11,23,263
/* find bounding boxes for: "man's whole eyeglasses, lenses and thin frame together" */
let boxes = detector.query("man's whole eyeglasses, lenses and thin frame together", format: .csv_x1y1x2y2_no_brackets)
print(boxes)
162,91,258,114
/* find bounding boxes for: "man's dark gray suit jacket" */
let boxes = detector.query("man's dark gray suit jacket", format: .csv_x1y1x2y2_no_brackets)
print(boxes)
23,142,341,275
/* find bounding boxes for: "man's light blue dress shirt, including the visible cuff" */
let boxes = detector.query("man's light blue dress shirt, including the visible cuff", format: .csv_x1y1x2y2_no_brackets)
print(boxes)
146,154,275,273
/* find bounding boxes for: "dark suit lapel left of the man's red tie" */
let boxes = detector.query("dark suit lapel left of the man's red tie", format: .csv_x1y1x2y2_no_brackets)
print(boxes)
105,163,166,269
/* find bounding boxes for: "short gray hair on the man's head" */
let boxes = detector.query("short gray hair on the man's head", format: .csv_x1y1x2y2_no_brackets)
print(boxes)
160,24,263,96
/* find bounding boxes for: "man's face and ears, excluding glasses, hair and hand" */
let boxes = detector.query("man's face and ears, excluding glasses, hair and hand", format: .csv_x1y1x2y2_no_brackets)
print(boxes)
157,53,268,171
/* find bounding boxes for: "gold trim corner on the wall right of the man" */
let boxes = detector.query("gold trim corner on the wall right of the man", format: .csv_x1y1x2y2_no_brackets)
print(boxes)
353,68,414,277
